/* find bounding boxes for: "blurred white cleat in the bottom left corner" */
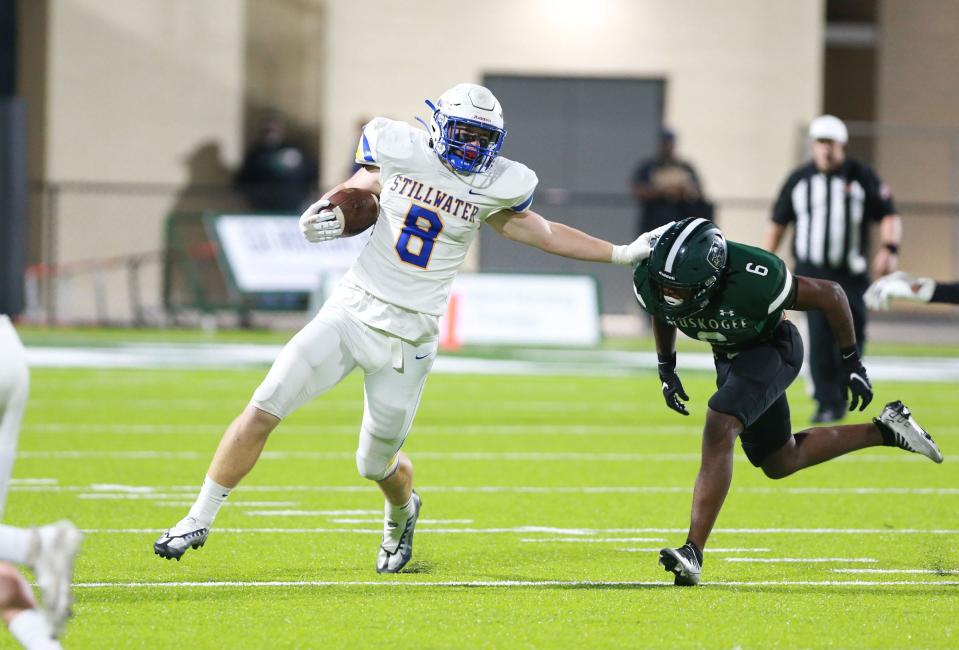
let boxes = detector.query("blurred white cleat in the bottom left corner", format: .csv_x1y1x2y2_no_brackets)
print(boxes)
30,520,83,637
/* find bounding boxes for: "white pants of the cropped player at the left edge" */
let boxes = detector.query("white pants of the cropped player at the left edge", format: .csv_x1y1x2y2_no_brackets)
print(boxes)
0,314,30,519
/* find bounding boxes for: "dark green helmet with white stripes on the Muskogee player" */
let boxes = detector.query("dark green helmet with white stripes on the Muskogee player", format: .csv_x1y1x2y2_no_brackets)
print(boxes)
647,218,728,318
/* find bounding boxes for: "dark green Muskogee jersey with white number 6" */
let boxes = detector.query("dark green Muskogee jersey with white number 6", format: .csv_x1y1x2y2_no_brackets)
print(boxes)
633,242,795,349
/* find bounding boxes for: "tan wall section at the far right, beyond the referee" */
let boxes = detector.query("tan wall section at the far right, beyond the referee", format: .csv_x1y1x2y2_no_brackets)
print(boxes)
876,0,959,278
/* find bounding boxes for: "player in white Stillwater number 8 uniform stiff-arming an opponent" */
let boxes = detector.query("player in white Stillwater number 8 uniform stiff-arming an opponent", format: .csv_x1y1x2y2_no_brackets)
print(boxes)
153,84,668,573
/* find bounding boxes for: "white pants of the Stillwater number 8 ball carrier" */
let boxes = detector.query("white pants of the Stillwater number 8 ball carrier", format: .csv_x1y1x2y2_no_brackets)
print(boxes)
250,301,437,481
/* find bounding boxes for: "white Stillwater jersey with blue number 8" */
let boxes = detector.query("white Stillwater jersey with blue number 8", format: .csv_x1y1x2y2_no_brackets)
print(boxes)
338,117,537,340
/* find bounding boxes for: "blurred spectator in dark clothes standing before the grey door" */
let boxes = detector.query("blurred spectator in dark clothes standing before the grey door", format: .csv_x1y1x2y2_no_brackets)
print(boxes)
633,127,713,232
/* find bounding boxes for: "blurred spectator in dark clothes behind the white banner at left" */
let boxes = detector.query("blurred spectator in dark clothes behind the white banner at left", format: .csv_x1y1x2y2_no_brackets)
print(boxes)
236,111,319,214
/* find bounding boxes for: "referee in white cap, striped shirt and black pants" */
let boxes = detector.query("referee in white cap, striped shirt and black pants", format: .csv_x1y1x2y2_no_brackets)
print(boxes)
763,115,902,422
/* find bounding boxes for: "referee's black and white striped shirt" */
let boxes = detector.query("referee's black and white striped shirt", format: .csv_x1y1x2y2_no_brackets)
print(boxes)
772,158,896,276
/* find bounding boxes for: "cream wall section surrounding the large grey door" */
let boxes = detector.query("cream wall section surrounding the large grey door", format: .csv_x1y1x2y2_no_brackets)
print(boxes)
323,0,824,242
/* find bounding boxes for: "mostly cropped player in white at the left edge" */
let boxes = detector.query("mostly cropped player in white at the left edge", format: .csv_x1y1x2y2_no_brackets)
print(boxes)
0,314,82,650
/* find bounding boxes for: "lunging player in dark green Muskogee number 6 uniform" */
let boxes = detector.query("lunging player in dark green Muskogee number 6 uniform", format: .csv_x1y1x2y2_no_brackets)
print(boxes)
633,219,942,585
